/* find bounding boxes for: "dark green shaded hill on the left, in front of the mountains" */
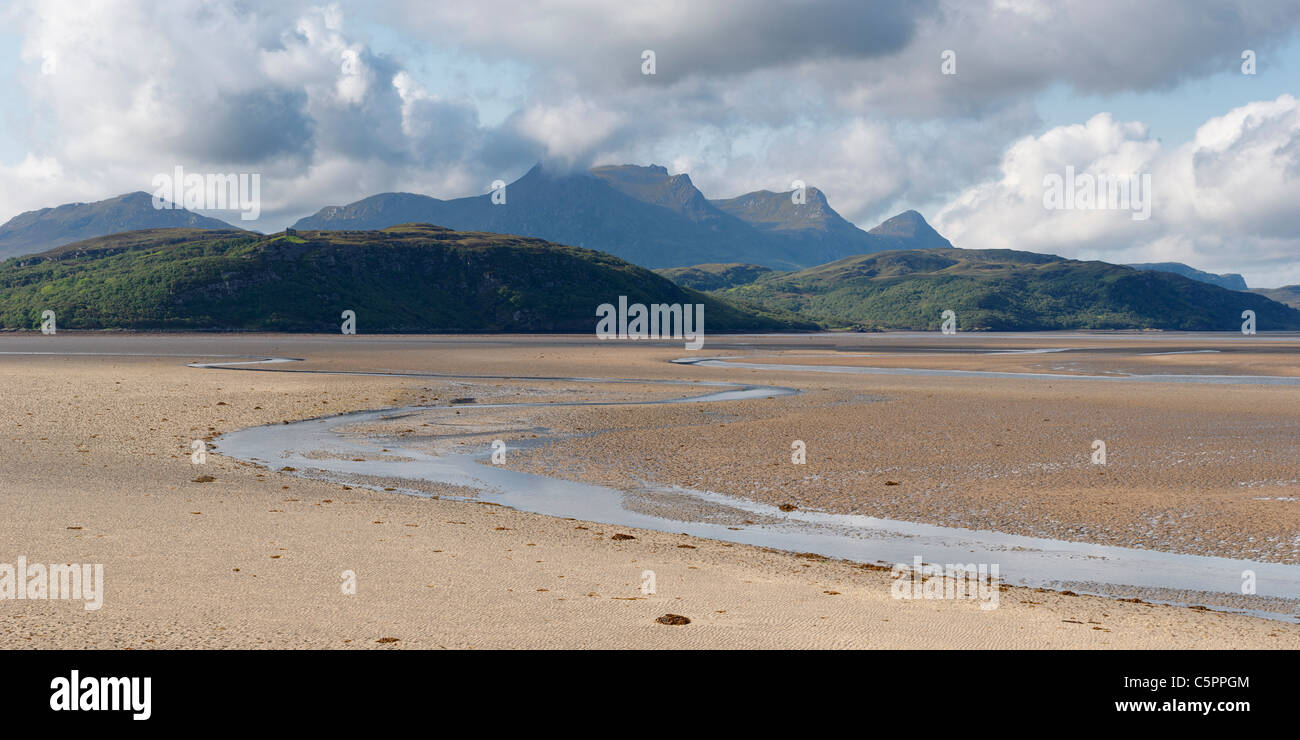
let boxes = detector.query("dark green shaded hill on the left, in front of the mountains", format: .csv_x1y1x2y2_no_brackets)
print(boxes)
0,224,815,333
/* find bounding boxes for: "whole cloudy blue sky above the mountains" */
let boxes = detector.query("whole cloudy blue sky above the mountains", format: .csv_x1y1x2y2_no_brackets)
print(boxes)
0,0,1300,287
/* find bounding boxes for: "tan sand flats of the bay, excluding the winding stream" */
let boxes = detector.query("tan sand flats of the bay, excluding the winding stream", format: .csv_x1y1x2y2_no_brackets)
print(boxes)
0,333,1300,648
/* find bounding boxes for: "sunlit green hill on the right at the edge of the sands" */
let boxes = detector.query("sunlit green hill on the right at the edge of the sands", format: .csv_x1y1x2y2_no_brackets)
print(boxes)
715,248,1300,330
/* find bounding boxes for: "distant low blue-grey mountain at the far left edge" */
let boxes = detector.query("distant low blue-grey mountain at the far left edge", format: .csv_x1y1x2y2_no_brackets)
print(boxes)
0,191,234,259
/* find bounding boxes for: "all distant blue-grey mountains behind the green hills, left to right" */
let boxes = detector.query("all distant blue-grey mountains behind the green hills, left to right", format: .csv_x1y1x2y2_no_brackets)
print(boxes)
0,165,1268,290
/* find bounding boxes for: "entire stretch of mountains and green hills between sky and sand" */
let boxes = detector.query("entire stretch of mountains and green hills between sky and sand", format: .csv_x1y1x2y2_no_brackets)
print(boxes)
0,165,1300,333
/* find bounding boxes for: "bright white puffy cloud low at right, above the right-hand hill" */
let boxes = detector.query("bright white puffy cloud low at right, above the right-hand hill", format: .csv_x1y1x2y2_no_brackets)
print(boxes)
935,95,1300,286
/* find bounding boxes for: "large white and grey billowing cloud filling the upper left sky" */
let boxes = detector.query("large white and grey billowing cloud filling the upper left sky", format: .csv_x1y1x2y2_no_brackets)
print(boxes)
0,0,538,229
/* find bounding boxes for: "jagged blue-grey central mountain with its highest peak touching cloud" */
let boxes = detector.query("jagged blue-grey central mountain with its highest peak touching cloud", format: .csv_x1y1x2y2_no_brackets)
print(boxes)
294,165,952,269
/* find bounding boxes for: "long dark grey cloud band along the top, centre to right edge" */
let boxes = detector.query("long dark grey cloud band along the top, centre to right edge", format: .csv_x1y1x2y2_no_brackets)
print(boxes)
384,0,1300,116
